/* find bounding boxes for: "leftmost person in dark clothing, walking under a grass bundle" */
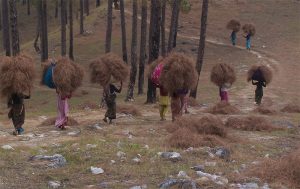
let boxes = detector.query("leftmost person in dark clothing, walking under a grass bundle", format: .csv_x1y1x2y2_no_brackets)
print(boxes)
7,93,30,135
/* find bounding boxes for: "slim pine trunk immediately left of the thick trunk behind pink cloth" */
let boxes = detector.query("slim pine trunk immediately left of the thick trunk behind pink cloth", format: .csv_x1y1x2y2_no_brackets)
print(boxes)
138,0,147,94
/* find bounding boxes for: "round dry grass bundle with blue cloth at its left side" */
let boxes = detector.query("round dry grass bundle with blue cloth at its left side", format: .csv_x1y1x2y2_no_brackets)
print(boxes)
53,57,84,95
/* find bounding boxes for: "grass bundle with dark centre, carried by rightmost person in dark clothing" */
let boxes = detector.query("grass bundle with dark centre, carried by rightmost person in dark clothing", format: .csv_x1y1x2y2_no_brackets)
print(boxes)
247,65,273,84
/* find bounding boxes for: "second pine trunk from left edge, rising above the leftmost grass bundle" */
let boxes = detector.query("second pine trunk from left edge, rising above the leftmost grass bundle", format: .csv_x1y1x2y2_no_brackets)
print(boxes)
9,0,20,56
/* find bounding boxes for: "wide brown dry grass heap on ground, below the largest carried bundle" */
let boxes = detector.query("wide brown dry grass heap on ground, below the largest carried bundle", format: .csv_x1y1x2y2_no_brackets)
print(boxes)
166,116,227,148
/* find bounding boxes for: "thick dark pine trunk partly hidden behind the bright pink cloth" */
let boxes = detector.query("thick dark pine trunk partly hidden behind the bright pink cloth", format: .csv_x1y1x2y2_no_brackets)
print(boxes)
146,0,161,103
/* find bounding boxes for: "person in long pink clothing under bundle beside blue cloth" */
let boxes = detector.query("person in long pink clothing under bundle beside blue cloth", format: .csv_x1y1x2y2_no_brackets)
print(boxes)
55,90,72,130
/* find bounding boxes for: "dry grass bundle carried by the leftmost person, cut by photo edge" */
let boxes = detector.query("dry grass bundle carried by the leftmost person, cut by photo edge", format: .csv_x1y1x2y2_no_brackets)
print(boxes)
0,54,36,97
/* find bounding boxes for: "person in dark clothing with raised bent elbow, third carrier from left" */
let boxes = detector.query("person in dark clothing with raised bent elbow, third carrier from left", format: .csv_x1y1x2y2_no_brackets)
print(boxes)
103,82,123,124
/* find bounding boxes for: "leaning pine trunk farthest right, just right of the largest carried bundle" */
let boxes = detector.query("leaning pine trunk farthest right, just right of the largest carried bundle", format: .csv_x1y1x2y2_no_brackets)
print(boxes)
190,0,208,98
